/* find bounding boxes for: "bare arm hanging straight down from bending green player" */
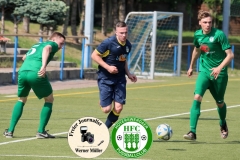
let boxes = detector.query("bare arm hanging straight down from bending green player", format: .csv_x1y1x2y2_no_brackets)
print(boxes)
38,45,52,77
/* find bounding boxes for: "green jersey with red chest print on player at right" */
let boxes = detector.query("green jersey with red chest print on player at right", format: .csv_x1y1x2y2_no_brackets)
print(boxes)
193,28,231,75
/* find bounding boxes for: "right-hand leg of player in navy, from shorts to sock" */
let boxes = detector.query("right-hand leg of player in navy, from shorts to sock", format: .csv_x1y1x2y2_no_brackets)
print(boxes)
106,77,126,128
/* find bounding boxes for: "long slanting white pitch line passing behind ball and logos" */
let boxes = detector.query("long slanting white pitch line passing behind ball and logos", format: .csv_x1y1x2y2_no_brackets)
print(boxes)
0,105,240,146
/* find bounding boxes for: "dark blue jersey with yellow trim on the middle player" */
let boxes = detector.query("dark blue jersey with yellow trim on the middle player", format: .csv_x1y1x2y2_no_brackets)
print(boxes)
96,36,132,78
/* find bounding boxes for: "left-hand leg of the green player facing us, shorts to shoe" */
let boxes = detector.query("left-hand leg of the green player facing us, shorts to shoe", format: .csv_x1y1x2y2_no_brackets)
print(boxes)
183,72,209,140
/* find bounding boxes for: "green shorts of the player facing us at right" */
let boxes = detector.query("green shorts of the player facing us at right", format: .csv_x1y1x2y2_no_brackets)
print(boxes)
194,72,228,104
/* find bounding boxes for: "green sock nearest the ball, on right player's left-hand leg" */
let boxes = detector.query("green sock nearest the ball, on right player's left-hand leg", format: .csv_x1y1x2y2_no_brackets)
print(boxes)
190,100,201,133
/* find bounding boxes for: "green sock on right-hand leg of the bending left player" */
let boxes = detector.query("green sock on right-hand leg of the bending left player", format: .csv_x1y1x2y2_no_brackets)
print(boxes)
38,102,53,133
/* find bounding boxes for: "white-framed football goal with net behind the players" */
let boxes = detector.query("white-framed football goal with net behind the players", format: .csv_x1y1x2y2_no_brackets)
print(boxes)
125,11,183,79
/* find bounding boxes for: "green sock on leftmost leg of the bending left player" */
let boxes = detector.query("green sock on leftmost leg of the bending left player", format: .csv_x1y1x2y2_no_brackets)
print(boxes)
8,101,25,132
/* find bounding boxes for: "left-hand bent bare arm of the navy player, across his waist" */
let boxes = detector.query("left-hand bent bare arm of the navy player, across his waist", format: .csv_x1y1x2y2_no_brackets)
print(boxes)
91,50,118,74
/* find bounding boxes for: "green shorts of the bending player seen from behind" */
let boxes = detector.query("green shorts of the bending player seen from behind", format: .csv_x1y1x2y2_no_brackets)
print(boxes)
18,71,53,99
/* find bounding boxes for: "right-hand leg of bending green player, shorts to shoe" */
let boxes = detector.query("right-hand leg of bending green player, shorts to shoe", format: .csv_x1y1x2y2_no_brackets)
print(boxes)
31,75,55,138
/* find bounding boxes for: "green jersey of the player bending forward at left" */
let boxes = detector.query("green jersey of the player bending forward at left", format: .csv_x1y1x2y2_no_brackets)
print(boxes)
19,41,58,71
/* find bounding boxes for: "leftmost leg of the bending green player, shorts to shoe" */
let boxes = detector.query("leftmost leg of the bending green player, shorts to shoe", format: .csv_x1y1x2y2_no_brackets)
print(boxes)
4,71,31,138
